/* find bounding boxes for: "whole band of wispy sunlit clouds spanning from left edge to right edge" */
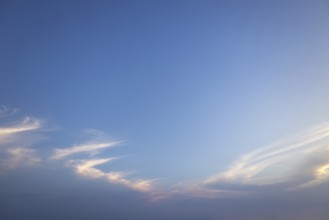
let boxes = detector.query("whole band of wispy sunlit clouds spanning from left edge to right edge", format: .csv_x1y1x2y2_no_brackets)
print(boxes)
0,107,329,200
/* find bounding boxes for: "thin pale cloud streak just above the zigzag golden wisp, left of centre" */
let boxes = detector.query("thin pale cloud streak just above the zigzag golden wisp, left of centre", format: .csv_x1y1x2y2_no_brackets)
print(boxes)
50,142,120,160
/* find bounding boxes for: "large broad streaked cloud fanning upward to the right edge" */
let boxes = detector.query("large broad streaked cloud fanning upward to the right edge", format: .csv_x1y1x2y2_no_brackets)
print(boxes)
204,123,329,189
